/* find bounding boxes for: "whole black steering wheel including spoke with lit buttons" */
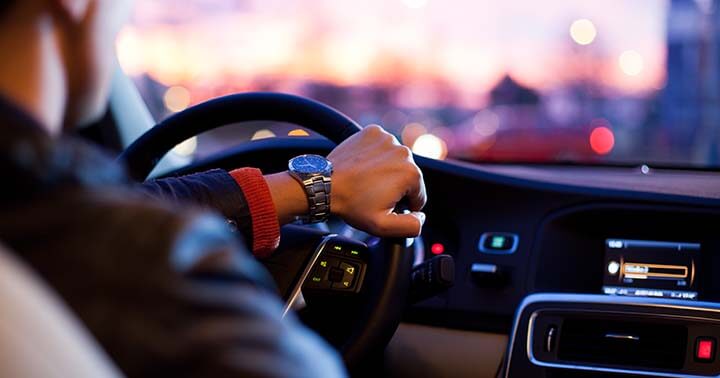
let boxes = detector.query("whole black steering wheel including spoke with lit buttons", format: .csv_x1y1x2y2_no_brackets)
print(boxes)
120,93,413,370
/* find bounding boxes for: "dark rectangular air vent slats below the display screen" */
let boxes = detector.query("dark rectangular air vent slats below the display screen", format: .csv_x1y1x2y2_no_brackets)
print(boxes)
558,318,688,369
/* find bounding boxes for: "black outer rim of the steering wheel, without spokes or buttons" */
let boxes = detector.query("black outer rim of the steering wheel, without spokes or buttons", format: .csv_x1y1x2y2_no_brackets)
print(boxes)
119,92,413,370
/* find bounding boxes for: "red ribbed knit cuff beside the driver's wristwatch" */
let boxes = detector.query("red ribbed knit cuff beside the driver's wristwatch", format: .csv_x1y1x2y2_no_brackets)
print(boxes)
230,168,280,258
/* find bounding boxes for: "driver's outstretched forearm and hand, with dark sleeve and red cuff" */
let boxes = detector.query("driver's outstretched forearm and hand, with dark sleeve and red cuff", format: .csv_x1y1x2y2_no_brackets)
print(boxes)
135,126,426,256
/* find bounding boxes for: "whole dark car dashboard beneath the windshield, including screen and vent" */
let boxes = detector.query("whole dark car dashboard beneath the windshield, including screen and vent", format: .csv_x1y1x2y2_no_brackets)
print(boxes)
179,138,720,377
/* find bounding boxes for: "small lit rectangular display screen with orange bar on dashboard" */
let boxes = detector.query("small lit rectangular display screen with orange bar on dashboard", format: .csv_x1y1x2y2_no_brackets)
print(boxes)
603,239,700,300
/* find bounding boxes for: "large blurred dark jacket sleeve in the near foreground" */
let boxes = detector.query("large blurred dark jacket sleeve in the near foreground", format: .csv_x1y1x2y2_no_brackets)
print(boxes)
0,191,346,378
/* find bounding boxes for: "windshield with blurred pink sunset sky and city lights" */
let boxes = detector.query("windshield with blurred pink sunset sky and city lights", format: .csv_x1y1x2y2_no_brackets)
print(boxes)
117,0,720,167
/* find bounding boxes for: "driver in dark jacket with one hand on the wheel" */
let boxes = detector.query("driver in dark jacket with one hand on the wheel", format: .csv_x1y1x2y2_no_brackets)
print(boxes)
0,0,425,377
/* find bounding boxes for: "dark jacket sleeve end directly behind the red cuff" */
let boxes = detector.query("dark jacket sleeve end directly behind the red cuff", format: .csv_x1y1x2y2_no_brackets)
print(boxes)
137,169,252,240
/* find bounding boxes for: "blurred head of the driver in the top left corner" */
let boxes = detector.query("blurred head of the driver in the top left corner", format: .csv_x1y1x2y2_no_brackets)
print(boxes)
0,0,133,130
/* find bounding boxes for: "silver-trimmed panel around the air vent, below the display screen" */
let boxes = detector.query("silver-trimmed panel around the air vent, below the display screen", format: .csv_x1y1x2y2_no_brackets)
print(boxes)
504,294,720,378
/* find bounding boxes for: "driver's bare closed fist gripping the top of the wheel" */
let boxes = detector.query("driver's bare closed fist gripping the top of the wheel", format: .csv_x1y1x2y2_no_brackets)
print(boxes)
328,125,426,237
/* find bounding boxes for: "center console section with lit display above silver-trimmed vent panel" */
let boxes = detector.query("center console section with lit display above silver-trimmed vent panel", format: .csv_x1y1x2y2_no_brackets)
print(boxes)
503,204,720,378
